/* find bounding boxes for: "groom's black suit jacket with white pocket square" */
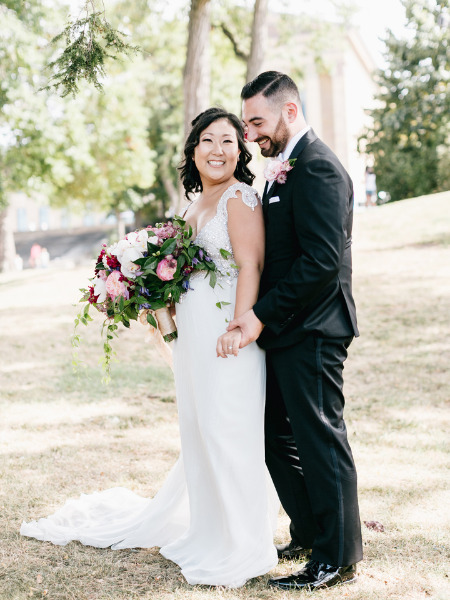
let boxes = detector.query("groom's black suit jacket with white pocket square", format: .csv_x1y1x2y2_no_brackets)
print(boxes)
253,129,359,349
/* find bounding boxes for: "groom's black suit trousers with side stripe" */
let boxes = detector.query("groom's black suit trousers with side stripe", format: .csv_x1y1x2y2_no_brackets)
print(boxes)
265,335,362,566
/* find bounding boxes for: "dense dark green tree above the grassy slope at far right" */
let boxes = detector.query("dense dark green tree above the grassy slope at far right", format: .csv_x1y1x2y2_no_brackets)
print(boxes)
359,0,450,200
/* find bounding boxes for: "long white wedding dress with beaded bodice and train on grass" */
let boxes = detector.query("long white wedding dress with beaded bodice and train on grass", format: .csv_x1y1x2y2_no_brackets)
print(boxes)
20,183,278,587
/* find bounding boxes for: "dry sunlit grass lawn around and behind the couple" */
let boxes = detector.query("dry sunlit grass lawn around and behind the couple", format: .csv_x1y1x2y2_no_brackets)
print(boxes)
0,192,450,600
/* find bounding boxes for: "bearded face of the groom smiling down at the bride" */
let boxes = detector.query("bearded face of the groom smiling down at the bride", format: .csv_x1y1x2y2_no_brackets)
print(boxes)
242,94,291,156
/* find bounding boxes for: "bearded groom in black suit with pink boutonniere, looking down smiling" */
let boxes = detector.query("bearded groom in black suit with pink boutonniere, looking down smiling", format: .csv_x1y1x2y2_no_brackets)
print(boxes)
229,71,362,590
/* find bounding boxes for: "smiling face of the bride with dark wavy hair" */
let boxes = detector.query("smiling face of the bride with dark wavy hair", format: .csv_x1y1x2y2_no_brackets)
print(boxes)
194,119,240,183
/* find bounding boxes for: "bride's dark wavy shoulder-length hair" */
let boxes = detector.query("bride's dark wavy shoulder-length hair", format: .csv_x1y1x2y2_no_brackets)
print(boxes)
178,107,255,200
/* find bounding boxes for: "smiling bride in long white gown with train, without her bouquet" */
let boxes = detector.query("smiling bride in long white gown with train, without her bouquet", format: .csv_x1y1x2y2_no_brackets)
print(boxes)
21,108,278,587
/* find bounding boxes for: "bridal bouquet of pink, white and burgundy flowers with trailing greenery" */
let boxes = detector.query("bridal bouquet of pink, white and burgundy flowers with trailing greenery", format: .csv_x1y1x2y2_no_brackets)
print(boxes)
72,217,216,376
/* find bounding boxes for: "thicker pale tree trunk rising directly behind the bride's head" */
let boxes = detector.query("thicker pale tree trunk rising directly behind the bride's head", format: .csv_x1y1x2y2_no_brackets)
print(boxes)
183,0,211,136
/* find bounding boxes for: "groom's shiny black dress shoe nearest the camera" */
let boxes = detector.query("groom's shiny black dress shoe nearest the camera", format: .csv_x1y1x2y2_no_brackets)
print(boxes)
269,560,357,591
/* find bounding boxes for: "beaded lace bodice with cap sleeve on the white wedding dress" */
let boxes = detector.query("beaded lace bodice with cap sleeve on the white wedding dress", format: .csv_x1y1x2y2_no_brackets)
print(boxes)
191,182,261,279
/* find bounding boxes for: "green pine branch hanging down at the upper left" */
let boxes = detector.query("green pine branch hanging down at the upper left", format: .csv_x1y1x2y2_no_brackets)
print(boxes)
41,0,140,97
